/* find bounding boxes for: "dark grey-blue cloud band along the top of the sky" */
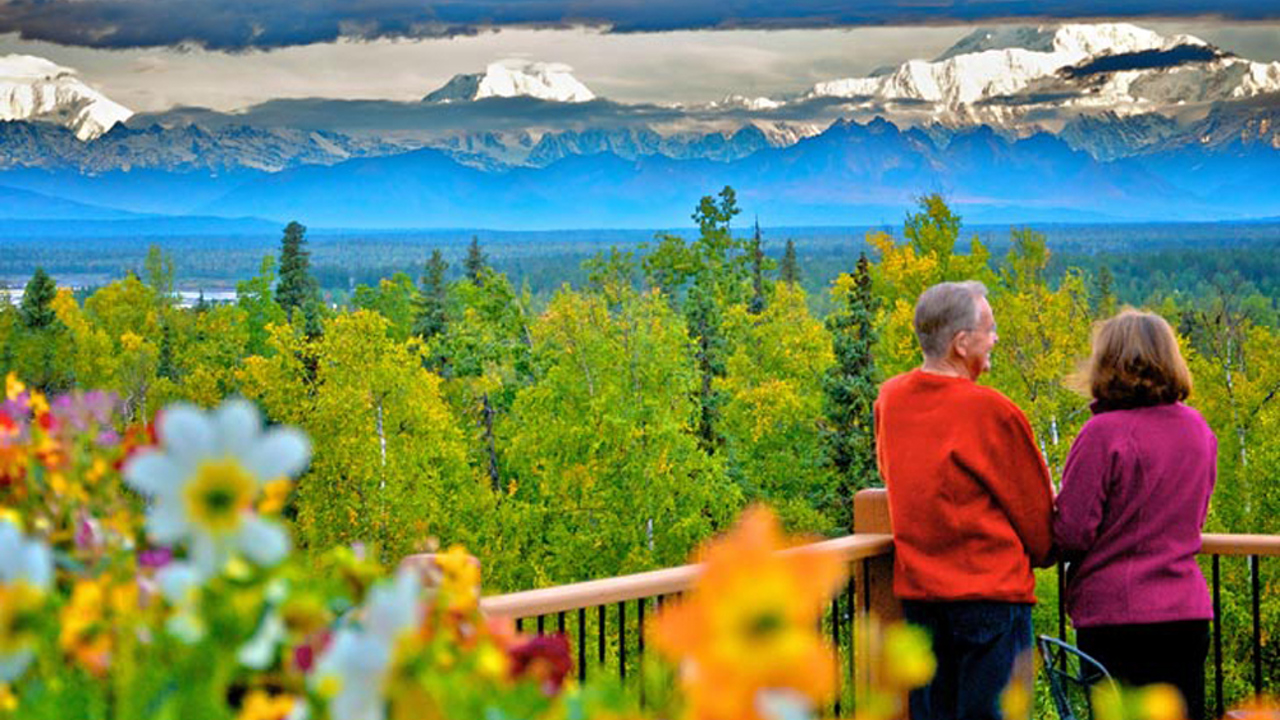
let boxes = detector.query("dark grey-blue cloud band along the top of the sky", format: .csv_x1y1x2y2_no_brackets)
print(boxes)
0,0,1280,50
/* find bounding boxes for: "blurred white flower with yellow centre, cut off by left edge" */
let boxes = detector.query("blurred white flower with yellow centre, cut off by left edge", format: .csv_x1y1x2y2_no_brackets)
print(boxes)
0,520,54,683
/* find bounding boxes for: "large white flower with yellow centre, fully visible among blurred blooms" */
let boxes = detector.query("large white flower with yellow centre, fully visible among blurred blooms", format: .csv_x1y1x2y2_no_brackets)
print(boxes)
124,400,311,579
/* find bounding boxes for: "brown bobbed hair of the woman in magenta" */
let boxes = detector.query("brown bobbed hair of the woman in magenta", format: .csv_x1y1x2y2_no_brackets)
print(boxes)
1073,309,1192,407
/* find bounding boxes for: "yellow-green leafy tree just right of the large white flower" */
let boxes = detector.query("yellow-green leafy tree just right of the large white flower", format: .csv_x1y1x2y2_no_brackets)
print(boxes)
238,310,481,562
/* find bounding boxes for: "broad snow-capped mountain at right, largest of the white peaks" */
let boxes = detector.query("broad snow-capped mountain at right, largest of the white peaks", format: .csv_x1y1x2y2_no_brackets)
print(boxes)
805,23,1280,129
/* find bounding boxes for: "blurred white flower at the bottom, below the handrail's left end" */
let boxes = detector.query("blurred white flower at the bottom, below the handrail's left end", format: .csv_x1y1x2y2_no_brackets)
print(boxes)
311,568,422,720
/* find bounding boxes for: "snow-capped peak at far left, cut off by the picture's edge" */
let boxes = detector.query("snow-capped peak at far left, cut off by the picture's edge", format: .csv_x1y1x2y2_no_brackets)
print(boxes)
0,55,133,140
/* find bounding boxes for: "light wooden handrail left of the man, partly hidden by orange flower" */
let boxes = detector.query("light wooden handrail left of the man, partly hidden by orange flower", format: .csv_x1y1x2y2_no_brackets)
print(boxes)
480,533,893,618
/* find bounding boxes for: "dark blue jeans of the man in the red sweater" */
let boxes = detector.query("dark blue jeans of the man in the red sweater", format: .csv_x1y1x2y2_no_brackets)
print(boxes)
902,600,1032,720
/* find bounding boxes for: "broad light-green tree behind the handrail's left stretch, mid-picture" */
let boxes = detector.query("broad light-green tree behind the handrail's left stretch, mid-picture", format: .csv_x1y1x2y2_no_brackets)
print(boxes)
495,283,741,587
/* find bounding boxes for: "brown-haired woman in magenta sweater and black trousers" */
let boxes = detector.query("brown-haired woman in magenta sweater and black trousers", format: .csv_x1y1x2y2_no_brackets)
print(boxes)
1053,310,1217,720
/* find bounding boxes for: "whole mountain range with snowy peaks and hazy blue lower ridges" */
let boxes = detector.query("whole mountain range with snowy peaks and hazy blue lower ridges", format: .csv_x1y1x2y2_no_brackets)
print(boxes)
0,23,1280,228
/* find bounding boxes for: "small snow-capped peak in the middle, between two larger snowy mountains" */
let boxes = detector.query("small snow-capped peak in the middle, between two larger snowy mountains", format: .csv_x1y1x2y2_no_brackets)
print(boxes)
422,59,595,102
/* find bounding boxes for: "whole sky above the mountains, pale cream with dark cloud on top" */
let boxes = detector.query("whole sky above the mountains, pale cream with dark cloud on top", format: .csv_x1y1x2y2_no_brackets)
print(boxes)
0,0,1280,111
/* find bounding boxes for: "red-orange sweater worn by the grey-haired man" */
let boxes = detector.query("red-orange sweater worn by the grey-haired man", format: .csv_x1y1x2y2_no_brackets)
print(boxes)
876,370,1053,602
